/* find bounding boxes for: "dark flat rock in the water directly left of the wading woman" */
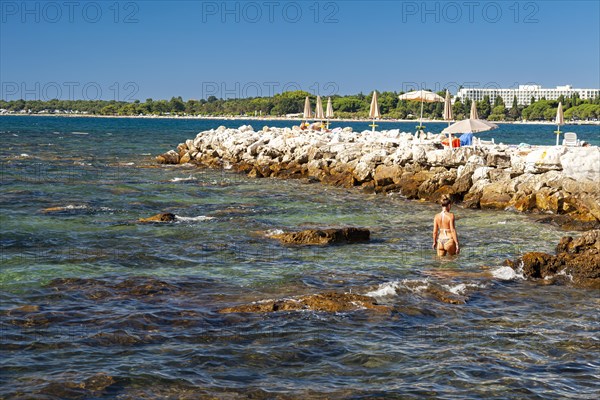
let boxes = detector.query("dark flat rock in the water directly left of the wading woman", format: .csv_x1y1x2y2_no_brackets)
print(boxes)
270,227,371,245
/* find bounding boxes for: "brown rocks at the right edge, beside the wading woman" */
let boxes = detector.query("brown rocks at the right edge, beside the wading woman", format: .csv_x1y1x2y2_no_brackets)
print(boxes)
507,230,600,289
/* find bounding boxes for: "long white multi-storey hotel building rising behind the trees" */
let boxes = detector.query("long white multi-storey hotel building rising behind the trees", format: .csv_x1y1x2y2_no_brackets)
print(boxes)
456,85,600,108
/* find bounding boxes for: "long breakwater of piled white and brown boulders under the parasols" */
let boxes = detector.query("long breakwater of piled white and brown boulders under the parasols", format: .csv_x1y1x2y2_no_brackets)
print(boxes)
157,125,600,230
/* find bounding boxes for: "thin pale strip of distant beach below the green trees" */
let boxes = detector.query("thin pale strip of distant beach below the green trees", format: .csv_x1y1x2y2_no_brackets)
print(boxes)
0,113,600,126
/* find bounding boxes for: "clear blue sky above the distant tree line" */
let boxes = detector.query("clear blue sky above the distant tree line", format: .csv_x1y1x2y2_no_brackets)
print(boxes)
0,0,600,101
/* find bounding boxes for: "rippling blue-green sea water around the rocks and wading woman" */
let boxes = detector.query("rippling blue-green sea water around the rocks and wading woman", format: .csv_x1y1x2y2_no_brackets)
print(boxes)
0,117,600,399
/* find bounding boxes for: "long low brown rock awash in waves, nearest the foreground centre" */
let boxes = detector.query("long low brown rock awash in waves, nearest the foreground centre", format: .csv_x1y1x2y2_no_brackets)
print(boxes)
219,293,390,314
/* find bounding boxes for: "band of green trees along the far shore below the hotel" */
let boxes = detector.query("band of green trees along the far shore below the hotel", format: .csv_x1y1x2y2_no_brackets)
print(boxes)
0,90,600,121
